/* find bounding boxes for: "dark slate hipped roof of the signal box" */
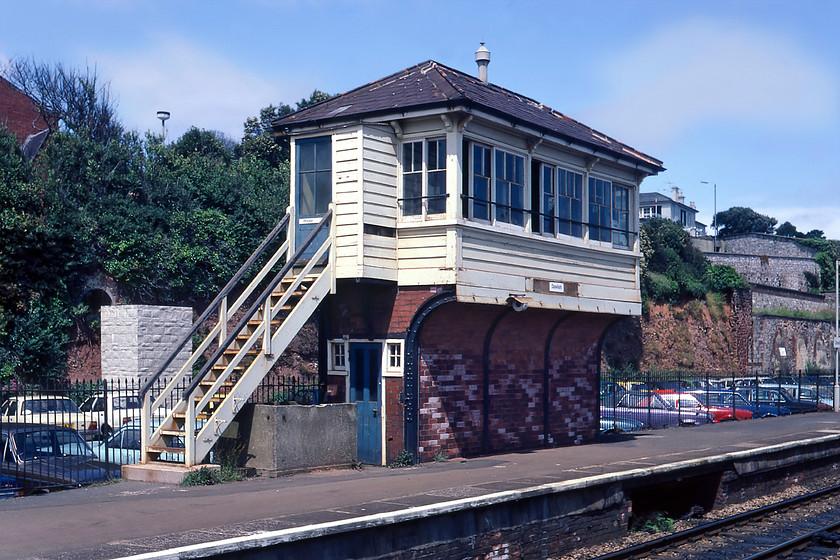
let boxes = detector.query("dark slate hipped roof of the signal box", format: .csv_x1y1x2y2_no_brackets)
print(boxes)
272,60,664,172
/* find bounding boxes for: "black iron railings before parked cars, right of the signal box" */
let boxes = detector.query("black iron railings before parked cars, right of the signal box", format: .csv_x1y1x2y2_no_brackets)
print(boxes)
600,371,834,429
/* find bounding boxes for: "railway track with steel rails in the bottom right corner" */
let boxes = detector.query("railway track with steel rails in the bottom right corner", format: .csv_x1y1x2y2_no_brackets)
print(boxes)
594,485,840,560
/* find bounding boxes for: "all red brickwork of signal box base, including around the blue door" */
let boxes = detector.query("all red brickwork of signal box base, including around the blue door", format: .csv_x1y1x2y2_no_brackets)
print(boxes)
327,282,614,462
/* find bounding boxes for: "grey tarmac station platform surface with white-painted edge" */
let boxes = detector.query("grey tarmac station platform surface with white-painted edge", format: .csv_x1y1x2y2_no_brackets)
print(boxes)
0,412,840,560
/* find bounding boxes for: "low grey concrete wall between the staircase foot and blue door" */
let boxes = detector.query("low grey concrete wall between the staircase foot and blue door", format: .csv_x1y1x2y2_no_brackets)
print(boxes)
236,403,357,473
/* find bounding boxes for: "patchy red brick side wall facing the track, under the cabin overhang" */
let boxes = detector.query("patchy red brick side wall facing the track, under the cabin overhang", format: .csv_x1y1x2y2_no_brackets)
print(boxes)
419,304,613,461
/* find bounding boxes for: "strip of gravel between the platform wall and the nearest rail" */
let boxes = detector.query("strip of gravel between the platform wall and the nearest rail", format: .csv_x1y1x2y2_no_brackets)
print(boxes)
551,476,840,560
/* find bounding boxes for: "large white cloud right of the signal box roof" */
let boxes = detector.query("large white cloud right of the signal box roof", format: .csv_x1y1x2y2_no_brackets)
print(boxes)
583,19,840,148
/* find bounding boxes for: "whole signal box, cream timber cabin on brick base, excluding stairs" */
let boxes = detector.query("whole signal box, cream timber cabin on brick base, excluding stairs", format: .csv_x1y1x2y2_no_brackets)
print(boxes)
273,52,664,464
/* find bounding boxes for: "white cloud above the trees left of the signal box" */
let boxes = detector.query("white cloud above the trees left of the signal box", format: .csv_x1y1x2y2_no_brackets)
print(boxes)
96,37,289,140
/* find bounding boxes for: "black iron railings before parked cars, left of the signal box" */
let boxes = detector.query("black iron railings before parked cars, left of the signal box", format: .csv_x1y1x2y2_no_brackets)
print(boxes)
0,375,323,497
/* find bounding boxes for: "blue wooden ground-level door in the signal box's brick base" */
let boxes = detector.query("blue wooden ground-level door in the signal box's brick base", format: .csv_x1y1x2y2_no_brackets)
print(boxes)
350,342,382,465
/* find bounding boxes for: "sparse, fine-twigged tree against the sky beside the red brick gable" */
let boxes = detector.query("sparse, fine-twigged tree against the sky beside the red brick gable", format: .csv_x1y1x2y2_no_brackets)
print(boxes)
2,58,123,144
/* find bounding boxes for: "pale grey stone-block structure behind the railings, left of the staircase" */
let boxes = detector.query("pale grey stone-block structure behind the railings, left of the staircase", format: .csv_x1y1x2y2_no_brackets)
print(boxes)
101,305,193,383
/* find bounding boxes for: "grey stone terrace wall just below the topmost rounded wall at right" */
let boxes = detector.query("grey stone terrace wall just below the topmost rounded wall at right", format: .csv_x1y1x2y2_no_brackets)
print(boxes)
706,252,820,292
